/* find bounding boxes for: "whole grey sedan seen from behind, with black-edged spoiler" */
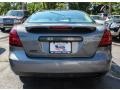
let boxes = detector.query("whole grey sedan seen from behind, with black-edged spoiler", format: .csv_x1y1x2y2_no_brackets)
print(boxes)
9,10,112,82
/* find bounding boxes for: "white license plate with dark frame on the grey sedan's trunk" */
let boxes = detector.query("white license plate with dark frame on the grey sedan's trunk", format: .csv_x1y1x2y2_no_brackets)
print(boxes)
50,42,71,54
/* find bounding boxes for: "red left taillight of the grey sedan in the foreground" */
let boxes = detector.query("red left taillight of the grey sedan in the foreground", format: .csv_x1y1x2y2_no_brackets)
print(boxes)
9,29,22,47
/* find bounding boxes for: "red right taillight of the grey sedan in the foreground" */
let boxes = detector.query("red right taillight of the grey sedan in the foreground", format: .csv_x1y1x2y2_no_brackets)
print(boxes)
99,30,112,47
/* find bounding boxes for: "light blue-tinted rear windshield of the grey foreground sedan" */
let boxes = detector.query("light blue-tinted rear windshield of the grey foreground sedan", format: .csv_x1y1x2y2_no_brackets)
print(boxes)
26,11,93,23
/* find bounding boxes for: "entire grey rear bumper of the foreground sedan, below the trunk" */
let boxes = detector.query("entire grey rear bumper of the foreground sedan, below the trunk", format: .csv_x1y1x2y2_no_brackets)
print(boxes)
9,47,111,76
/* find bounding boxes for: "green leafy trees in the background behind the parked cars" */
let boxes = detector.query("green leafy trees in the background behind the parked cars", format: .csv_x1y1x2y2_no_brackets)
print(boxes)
0,2,120,15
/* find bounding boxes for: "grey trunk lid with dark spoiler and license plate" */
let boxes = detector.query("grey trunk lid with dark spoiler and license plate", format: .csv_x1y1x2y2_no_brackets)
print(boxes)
18,25,103,57
